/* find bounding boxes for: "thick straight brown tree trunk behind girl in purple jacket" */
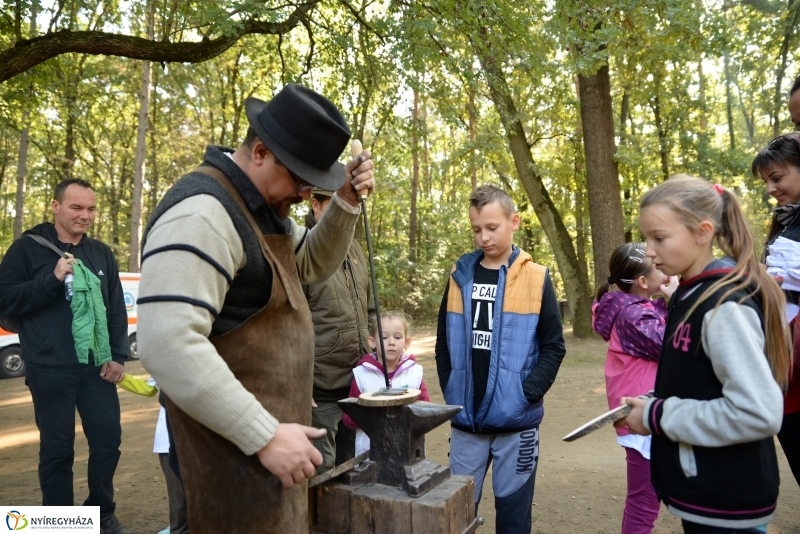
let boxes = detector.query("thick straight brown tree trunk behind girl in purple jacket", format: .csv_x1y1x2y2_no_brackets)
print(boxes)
578,64,625,294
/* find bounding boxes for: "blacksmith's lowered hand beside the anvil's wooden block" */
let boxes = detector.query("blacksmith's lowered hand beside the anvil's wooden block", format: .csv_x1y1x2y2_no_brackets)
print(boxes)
256,423,327,488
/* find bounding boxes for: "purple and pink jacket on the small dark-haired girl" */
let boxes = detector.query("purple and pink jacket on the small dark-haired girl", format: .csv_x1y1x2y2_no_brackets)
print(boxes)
592,291,667,436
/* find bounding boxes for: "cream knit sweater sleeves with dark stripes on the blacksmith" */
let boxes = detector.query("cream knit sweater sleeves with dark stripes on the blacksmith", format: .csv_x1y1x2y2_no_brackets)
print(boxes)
137,150,360,454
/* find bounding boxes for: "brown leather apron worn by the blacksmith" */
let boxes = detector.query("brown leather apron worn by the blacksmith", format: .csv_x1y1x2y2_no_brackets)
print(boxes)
167,167,314,534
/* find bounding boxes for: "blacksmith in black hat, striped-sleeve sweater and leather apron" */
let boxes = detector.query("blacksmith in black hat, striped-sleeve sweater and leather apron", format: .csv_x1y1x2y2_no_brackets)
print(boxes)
137,84,375,533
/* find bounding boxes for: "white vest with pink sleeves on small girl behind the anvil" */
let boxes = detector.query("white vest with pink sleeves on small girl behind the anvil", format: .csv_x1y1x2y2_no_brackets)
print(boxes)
342,353,431,456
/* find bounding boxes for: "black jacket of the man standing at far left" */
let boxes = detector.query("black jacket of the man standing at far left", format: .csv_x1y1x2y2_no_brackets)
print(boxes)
0,223,128,367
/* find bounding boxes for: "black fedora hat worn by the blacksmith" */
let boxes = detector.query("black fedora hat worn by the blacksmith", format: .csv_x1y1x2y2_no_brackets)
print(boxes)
244,83,350,191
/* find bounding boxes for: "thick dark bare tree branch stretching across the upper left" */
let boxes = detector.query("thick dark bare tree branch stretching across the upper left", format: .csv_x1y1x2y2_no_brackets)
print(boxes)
0,0,321,83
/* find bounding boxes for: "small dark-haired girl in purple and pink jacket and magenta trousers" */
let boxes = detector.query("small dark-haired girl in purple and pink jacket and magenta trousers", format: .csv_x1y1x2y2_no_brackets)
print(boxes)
592,243,678,534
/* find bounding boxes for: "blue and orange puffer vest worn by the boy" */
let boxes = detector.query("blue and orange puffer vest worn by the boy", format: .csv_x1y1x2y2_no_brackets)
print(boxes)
444,246,547,432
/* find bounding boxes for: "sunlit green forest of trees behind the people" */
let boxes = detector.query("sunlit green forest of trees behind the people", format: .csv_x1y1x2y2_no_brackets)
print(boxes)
0,0,800,336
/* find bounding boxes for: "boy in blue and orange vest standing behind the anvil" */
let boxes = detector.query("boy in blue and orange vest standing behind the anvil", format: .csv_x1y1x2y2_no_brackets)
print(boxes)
436,185,565,534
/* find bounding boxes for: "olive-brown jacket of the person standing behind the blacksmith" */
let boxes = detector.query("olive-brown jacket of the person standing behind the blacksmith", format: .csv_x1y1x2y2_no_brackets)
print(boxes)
303,211,375,401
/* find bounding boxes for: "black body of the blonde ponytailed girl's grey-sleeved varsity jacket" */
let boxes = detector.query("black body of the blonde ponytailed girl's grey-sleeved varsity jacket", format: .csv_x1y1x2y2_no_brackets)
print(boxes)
649,268,779,528
